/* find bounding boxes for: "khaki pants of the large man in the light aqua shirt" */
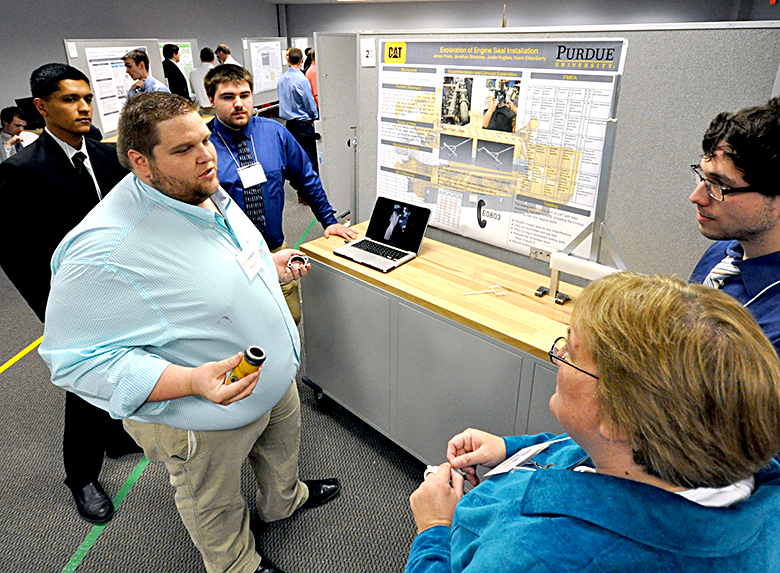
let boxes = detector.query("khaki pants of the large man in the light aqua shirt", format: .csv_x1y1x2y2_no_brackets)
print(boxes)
124,383,309,573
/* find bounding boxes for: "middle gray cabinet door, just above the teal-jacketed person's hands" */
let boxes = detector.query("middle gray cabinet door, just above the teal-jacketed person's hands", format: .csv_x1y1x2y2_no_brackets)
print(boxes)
397,303,523,464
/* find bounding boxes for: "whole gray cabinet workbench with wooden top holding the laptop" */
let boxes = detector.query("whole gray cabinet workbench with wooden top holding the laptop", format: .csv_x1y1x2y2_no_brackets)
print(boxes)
301,223,580,464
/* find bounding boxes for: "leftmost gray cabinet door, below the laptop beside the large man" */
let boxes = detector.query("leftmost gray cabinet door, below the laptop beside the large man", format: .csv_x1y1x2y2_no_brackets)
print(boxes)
301,261,390,433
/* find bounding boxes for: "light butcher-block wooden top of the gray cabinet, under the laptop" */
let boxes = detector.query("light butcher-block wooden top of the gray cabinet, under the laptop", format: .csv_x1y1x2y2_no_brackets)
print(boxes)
301,223,582,360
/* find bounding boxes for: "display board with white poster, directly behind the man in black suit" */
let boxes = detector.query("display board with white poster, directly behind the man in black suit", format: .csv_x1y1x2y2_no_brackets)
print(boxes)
65,38,165,136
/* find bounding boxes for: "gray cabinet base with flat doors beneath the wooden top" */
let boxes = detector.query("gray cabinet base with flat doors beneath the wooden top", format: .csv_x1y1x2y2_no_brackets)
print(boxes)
301,260,560,464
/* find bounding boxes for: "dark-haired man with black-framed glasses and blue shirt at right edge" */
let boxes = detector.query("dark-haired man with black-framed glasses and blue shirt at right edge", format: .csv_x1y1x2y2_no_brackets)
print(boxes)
690,98,780,352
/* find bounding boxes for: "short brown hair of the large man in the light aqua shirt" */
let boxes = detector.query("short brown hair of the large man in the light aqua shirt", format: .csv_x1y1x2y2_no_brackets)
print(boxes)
116,92,198,169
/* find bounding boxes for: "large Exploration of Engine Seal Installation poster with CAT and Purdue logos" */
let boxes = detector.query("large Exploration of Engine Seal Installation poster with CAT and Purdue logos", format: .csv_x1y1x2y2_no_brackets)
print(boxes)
377,38,627,259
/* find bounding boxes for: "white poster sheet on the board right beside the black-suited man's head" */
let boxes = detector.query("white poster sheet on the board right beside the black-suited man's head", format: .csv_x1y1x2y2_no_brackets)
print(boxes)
84,46,148,134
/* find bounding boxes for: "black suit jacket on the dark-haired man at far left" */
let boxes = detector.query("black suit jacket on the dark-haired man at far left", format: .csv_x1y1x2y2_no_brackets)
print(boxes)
0,131,128,321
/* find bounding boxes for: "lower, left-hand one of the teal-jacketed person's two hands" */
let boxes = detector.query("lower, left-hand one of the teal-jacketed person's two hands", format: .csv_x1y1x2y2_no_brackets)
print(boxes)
409,463,463,533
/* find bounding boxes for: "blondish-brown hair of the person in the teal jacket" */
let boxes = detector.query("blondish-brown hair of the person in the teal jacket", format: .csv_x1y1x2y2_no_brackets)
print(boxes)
571,272,780,488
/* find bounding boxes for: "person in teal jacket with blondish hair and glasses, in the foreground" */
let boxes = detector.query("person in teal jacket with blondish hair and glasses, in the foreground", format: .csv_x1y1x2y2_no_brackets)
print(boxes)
406,272,780,573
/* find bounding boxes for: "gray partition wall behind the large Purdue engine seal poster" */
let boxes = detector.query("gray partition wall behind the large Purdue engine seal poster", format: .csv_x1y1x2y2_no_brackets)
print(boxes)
356,22,780,277
